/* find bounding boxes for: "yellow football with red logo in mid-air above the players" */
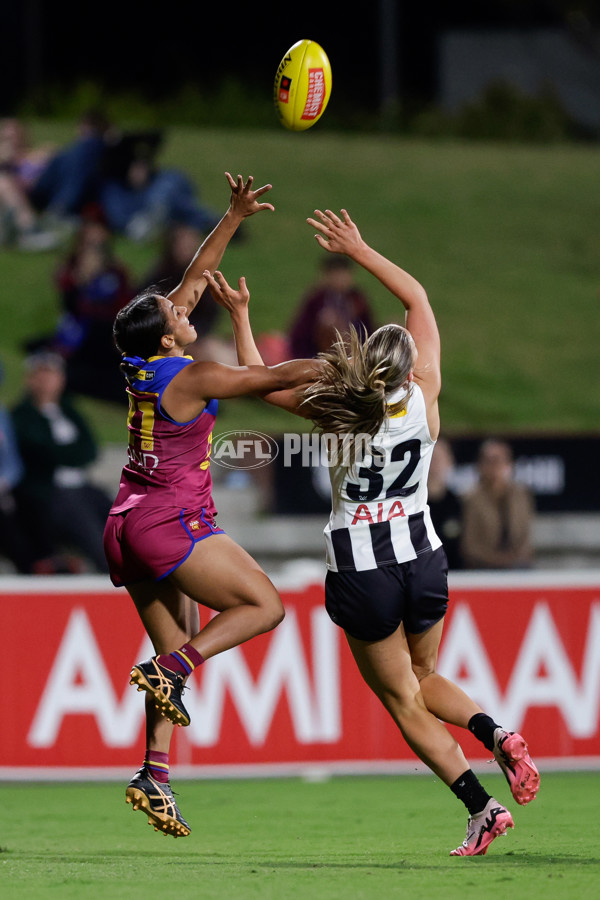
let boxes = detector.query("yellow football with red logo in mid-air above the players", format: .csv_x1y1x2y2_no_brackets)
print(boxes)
274,40,331,131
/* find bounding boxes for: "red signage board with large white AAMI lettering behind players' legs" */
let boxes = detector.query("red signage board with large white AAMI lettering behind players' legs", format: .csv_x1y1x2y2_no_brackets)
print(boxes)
0,572,600,778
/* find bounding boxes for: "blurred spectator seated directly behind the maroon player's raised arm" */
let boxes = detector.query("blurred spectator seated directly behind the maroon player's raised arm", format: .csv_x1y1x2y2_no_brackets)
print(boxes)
140,223,237,362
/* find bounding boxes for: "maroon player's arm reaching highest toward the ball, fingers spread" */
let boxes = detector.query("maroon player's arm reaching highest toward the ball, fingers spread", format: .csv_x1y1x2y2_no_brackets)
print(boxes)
168,172,275,314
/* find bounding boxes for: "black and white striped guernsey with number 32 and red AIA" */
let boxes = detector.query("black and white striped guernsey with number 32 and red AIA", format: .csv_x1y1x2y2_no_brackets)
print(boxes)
324,382,442,572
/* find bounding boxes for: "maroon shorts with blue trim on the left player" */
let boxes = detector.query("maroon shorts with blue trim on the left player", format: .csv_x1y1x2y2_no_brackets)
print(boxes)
104,506,225,587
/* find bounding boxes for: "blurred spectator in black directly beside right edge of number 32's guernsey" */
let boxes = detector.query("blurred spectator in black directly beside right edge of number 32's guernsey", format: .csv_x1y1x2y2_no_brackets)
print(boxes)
427,437,463,571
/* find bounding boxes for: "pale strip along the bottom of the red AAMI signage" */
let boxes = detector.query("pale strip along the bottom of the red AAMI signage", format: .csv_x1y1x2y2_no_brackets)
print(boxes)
0,756,600,781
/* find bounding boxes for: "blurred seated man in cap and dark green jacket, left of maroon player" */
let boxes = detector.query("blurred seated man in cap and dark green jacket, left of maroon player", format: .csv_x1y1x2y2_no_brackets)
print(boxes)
12,353,111,572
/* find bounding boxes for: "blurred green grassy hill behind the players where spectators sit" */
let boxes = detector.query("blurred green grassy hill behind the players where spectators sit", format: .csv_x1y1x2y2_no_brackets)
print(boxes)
0,122,600,440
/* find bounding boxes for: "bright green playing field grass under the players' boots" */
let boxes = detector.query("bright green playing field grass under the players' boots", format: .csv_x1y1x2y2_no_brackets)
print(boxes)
0,773,600,900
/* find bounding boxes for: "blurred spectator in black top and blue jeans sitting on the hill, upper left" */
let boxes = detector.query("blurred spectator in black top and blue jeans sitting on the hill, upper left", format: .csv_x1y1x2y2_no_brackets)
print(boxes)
98,132,220,241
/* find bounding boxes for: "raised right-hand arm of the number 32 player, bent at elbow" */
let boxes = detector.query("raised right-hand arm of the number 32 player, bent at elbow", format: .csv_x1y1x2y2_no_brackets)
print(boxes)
307,209,441,406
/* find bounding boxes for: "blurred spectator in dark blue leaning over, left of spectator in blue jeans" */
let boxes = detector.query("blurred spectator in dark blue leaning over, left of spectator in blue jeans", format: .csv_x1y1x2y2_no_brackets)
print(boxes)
30,109,113,225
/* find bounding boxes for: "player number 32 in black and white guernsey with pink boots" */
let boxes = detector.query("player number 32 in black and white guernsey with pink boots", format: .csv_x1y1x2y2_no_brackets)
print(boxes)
205,210,539,856
